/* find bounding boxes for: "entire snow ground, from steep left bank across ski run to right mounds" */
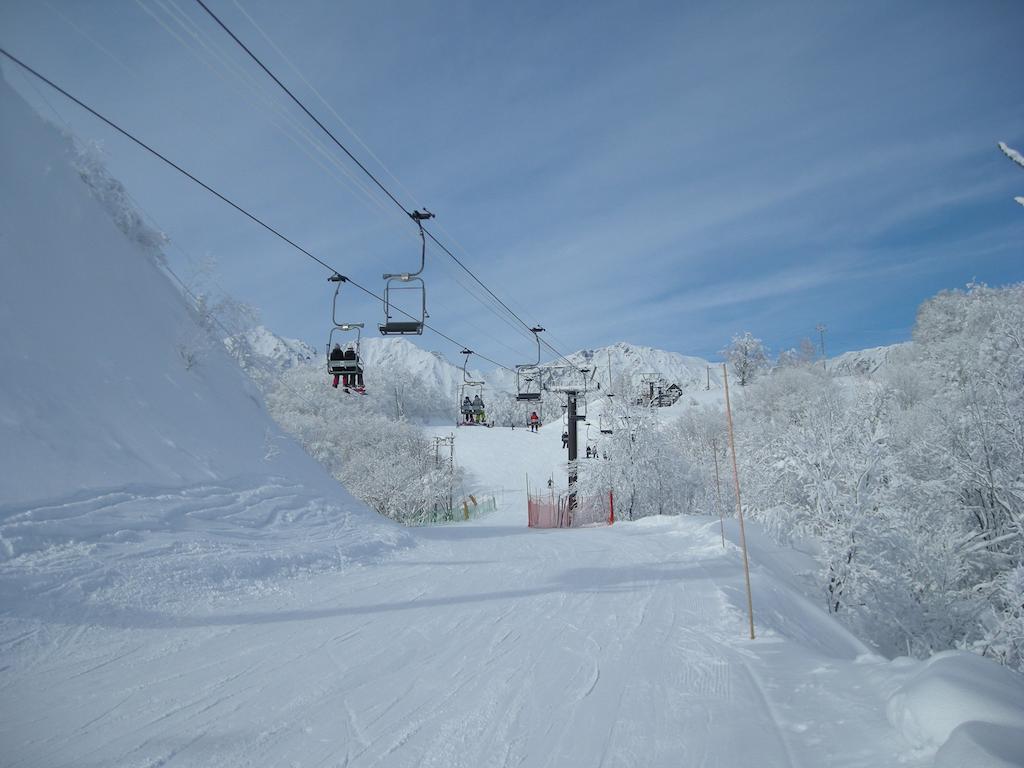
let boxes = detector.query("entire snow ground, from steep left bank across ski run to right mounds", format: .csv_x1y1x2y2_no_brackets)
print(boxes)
0,72,1024,768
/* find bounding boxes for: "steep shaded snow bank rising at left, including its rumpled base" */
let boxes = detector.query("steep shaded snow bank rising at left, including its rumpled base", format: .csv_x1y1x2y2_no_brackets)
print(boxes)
0,73,404,581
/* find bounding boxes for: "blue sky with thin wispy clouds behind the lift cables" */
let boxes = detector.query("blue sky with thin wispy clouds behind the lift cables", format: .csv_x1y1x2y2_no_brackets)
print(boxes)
0,0,1024,365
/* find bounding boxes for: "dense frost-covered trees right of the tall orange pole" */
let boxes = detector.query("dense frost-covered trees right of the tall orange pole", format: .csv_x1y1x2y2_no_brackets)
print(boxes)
679,285,1024,668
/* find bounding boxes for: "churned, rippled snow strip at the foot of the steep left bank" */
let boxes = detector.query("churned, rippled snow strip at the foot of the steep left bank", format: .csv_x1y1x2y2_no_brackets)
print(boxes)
0,477,409,618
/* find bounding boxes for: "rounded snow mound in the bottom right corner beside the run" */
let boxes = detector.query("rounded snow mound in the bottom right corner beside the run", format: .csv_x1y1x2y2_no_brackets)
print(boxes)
888,651,1024,766
